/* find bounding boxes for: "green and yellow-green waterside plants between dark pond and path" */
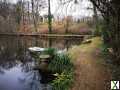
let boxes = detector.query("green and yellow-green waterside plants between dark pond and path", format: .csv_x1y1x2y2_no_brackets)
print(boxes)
48,54,74,90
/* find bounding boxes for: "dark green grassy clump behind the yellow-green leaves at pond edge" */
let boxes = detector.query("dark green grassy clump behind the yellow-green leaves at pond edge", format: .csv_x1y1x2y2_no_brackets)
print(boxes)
49,54,73,73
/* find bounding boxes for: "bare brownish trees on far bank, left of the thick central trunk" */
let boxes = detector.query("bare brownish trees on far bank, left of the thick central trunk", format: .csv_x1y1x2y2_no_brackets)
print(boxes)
0,0,47,33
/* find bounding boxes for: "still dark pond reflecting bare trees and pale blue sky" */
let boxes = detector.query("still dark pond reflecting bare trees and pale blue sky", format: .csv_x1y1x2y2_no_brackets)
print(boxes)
0,36,82,90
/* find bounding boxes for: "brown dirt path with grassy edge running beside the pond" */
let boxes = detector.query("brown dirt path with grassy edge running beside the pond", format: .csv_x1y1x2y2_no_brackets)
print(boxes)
68,38,111,90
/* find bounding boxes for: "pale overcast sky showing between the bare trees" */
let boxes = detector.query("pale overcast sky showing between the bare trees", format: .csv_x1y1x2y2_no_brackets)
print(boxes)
11,0,93,18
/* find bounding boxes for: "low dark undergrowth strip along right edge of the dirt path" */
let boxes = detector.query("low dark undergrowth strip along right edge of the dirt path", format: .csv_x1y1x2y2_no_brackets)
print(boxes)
101,44,120,80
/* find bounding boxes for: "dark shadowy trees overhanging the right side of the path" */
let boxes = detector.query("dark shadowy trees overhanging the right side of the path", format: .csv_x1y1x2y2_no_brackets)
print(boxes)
90,0,120,64
